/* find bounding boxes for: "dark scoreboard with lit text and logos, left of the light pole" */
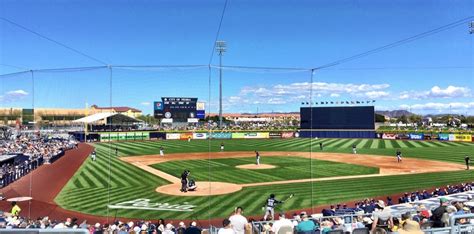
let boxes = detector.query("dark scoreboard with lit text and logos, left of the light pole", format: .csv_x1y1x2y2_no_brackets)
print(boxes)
154,97,204,122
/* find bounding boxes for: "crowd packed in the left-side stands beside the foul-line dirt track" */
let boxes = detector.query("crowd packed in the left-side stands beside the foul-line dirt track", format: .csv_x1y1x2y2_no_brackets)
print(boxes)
0,133,77,187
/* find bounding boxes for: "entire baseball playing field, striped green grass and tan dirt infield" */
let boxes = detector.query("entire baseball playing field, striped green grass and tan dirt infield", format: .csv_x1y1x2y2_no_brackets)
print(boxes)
55,138,474,220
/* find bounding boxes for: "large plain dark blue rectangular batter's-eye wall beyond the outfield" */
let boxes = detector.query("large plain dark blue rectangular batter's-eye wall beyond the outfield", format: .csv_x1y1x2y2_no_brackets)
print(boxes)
299,106,375,138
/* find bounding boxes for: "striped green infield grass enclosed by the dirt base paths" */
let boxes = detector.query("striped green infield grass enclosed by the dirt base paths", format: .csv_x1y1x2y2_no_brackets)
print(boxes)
152,156,379,184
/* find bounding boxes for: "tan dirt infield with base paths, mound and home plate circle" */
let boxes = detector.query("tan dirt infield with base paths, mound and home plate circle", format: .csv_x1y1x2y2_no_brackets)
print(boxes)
121,151,464,196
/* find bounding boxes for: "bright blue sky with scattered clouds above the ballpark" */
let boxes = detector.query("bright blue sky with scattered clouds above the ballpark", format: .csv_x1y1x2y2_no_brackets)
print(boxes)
0,0,474,114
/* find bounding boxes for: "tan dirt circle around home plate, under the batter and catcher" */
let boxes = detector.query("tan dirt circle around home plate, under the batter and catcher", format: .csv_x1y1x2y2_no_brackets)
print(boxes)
155,181,242,197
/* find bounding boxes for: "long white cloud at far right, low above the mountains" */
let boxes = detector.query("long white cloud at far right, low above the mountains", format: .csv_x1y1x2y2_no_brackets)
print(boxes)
399,85,471,99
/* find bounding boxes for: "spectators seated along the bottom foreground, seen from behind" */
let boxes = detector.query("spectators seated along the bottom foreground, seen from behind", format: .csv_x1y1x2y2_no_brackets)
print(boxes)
0,183,474,234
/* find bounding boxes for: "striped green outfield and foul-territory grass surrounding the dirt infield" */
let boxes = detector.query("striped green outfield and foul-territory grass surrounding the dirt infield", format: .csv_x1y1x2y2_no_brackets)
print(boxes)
56,139,474,219
